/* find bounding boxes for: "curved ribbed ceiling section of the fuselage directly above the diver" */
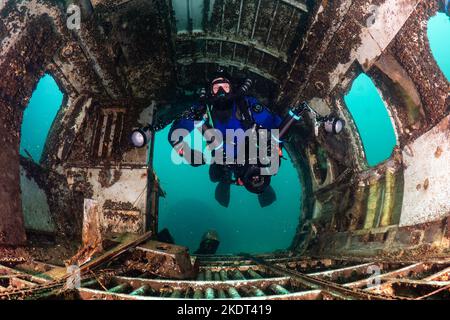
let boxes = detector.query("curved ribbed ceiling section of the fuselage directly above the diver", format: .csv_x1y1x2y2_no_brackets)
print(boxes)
172,0,310,84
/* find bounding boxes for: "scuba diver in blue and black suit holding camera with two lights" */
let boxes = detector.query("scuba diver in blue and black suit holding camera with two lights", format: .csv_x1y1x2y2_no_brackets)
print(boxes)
131,69,344,207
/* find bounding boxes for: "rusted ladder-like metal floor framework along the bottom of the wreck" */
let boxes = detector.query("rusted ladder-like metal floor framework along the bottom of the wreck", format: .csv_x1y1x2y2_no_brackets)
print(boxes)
0,253,450,300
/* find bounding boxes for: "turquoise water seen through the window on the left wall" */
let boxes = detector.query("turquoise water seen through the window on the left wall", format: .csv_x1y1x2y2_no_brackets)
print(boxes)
20,74,64,162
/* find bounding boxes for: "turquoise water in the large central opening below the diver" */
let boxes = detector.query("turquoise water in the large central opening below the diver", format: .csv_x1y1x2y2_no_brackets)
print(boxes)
154,127,301,253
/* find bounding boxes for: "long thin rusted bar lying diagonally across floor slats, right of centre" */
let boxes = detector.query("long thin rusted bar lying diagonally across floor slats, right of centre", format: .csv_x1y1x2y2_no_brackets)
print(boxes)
246,255,392,300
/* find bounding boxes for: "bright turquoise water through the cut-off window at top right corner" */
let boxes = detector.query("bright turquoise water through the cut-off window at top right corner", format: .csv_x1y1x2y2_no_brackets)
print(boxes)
427,12,450,80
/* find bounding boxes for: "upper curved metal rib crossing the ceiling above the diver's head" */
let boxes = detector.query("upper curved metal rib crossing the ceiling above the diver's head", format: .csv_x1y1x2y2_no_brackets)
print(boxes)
177,34,287,63
